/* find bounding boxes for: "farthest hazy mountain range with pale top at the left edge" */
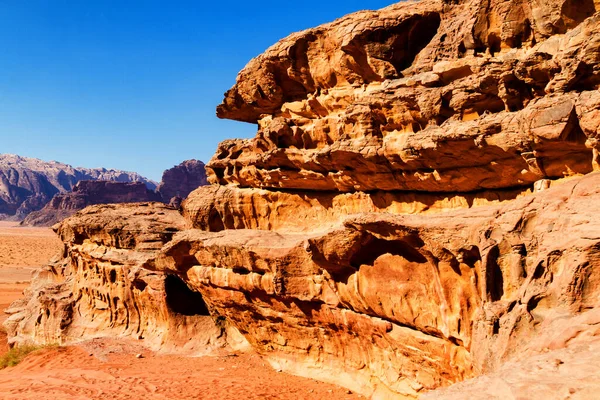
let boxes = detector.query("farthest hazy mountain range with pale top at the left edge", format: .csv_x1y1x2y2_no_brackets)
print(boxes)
0,154,157,220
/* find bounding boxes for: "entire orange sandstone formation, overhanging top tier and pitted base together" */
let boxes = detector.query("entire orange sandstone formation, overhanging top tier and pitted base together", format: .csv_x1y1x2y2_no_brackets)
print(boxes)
8,0,600,399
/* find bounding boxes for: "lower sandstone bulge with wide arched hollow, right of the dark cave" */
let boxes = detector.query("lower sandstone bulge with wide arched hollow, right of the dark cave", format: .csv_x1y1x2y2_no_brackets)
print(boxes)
169,173,600,397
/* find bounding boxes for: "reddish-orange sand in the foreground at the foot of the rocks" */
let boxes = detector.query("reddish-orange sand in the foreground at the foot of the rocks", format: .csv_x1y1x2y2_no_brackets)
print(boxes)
0,340,360,400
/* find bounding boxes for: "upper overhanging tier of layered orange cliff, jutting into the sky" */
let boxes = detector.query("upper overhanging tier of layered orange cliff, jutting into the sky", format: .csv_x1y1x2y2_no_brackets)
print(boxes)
207,0,600,193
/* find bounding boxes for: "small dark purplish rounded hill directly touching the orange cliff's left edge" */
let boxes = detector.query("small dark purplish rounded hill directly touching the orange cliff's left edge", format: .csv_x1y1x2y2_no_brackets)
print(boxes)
157,160,208,208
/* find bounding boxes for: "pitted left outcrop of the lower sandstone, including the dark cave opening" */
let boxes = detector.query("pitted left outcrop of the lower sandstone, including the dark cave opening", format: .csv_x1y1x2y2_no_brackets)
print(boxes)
5,203,239,354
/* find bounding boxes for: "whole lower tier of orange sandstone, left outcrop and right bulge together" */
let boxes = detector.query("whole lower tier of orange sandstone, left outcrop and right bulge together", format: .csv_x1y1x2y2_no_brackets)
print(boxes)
6,173,600,398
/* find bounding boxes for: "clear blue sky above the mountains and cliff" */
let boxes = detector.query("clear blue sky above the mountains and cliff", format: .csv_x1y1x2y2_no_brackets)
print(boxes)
0,0,396,180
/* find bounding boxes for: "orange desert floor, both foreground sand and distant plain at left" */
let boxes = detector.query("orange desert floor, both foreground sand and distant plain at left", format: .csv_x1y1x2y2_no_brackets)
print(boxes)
0,222,361,400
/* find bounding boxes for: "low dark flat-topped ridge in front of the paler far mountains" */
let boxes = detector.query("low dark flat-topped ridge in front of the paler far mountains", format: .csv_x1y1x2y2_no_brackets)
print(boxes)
22,181,161,226
